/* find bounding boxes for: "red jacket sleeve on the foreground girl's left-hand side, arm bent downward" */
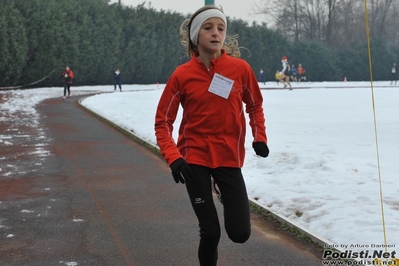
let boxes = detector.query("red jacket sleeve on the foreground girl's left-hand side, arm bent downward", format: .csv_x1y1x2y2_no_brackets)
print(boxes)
155,75,183,165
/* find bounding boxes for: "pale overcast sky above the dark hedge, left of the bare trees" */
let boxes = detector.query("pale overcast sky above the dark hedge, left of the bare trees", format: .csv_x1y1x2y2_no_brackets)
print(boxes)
111,0,264,24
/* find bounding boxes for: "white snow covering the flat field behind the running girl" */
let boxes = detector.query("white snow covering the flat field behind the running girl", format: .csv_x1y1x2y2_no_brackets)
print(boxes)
0,82,399,260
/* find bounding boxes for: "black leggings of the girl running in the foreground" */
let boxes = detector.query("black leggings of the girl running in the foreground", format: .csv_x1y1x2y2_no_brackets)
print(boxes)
186,164,251,266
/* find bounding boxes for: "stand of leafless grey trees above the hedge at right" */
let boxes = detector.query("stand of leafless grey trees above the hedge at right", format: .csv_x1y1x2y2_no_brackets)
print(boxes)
258,0,399,48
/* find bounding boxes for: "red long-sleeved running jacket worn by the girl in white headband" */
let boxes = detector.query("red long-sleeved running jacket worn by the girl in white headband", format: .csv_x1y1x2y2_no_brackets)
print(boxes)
155,51,267,168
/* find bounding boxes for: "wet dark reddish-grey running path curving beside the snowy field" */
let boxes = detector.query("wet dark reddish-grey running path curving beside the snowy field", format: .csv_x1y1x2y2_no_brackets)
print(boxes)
0,94,321,266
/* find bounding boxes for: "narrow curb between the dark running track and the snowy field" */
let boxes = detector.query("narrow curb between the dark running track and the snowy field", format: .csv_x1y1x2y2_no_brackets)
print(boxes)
78,96,344,252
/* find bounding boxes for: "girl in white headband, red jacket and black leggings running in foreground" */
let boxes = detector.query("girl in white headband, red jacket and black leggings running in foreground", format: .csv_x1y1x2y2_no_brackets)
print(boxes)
155,5,269,266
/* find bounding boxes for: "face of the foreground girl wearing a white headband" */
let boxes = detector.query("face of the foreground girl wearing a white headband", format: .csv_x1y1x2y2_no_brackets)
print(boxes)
198,18,226,54
